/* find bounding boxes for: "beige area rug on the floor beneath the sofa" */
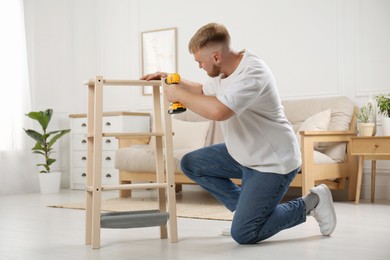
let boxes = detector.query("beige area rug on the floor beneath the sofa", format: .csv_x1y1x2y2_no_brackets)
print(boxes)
48,191,233,221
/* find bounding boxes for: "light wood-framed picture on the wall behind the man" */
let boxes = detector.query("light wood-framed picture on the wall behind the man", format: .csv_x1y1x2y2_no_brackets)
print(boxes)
141,28,177,96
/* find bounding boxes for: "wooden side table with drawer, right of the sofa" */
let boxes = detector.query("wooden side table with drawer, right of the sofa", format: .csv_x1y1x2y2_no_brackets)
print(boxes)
351,136,390,204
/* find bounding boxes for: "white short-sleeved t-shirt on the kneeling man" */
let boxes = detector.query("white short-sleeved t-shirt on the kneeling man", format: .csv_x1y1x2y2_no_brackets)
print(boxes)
203,50,301,174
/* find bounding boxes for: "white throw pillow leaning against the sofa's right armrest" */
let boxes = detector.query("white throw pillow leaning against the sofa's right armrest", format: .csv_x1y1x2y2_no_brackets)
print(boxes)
296,109,331,145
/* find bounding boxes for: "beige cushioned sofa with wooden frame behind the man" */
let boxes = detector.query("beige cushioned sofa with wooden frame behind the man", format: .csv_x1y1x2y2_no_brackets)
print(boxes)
115,96,357,200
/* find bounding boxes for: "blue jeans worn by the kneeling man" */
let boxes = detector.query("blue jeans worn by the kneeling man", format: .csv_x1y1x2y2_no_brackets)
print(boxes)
181,144,306,244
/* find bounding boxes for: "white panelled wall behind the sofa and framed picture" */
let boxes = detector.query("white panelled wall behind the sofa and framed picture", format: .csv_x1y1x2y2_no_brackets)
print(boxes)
24,0,390,199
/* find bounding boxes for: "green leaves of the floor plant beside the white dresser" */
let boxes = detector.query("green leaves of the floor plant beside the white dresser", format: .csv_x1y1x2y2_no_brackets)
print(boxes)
24,109,70,173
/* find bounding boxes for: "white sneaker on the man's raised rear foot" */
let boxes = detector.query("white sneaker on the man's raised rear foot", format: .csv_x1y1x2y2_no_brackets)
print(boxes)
309,184,337,236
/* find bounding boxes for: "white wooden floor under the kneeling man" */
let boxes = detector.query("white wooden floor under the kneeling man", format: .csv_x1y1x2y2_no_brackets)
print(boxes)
0,190,390,260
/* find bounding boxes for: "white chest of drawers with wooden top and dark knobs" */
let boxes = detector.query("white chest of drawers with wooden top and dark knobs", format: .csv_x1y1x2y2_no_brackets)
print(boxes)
69,112,150,190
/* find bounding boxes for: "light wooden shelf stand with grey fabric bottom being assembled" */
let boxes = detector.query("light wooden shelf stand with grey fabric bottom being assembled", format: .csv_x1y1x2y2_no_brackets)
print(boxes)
85,76,178,249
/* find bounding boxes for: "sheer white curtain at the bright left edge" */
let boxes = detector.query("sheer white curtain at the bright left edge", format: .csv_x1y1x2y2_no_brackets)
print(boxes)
0,0,38,195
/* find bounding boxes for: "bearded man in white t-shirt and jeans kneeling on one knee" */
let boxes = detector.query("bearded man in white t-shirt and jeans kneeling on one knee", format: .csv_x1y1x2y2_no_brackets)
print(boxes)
141,23,336,244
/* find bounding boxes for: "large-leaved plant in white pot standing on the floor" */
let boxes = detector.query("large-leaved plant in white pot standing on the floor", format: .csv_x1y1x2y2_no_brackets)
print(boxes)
24,109,70,193
